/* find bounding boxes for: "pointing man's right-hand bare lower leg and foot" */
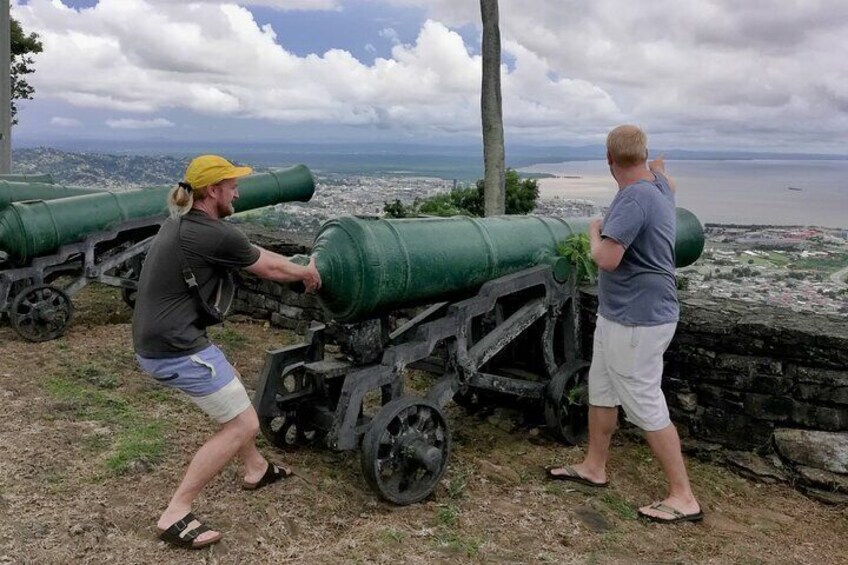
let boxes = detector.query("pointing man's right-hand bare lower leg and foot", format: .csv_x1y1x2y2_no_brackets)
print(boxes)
639,424,701,519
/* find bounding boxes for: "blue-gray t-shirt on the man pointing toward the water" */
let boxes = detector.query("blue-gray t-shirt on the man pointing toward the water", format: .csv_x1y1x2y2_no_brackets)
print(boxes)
598,174,679,326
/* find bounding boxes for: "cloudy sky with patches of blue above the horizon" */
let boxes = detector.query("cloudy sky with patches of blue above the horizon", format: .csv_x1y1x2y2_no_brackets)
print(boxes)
11,0,848,154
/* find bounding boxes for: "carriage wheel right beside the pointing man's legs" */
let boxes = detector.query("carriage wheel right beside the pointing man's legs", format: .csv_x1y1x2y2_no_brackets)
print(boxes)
545,362,589,445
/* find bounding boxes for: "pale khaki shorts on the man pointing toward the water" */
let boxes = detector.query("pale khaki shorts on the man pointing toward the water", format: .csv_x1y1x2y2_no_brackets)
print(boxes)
589,316,677,432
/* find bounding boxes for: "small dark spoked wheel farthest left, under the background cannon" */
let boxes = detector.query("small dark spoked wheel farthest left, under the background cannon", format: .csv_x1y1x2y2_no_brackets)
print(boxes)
9,284,74,342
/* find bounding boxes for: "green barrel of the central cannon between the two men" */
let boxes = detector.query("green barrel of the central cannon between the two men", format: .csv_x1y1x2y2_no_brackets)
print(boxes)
312,208,704,322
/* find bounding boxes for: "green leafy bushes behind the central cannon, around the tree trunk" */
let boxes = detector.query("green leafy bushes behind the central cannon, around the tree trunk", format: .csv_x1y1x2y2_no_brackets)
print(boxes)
383,169,539,218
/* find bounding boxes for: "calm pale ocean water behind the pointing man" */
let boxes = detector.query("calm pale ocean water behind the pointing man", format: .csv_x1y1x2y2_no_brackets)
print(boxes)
520,160,848,228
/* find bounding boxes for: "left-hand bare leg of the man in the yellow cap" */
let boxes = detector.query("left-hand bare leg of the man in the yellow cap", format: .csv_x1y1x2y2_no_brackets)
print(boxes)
156,407,264,542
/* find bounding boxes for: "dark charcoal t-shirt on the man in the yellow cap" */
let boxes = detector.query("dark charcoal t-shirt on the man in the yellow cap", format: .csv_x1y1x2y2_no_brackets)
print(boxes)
133,210,259,358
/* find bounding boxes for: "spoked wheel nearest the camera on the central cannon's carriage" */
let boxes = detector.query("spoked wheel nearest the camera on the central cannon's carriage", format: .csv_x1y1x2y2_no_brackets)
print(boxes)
361,396,450,505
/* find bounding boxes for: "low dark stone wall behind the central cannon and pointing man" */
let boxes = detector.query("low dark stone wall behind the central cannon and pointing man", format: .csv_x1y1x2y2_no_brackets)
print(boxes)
233,234,848,503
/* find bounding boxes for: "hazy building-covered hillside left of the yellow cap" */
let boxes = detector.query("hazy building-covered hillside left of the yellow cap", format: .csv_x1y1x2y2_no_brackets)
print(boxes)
12,147,189,189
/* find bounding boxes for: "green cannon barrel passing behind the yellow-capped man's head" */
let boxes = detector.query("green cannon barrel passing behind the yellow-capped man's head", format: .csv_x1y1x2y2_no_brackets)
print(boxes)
0,165,315,265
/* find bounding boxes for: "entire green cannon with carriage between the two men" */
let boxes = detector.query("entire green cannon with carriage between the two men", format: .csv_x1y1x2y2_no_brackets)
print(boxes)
253,209,704,504
